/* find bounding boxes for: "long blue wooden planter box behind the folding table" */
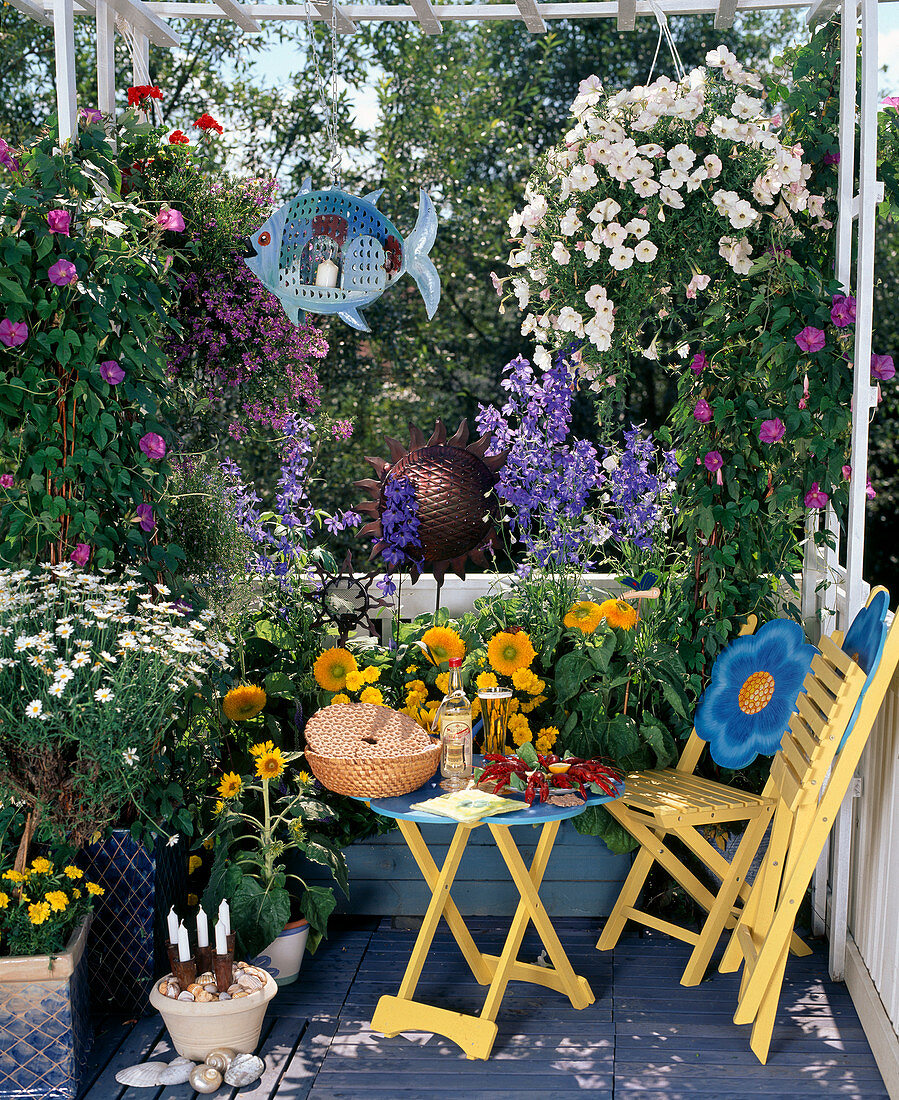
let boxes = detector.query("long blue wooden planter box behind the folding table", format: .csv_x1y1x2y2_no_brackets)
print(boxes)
298,821,631,917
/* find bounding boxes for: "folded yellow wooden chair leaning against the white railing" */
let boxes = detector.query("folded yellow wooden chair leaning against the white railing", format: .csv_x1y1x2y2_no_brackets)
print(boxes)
720,589,899,1064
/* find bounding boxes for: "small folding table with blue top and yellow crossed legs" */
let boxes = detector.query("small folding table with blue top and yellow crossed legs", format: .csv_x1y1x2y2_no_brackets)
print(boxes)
360,777,623,1058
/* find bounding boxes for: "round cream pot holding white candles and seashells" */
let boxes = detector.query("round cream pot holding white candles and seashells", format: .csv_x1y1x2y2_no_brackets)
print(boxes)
150,977,277,1062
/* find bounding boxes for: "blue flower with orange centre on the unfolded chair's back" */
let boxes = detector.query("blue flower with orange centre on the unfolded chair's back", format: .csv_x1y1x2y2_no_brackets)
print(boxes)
695,619,818,768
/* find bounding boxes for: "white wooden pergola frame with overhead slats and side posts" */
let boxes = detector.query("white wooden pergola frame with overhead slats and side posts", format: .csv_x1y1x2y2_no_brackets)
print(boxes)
17,0,882,979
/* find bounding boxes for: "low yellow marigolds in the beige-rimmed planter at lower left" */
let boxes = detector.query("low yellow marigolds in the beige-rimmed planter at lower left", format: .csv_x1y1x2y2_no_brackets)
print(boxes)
0,850,103,956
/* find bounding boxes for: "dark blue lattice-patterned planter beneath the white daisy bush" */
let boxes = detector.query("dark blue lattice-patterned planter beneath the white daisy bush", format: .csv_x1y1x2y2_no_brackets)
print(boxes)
83,828,187,1013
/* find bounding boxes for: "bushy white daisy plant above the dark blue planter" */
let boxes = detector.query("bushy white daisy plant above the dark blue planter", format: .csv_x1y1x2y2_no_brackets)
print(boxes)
0,563,228,846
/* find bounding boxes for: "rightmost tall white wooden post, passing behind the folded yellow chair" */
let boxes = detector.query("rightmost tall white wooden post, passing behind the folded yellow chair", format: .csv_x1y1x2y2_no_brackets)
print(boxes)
830,0,879,981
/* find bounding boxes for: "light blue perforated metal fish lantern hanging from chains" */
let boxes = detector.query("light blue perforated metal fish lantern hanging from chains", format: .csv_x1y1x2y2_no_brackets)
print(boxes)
243,179,440,332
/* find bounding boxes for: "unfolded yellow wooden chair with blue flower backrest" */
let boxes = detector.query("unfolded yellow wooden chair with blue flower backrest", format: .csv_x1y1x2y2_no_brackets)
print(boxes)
596,616,836,986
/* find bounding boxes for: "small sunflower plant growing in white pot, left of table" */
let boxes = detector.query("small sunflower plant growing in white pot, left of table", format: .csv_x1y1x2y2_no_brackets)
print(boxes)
202,740,347,958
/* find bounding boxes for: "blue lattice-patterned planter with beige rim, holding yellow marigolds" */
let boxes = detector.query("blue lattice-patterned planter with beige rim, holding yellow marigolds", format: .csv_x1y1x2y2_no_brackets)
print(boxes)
0,922,92,1100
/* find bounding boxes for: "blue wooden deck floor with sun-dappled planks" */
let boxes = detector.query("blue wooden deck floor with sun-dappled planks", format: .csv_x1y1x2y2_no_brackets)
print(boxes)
83,919,888,1100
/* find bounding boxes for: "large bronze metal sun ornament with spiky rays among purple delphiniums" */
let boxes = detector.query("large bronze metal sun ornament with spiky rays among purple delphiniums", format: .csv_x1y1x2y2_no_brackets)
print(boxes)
355,420,506,584
